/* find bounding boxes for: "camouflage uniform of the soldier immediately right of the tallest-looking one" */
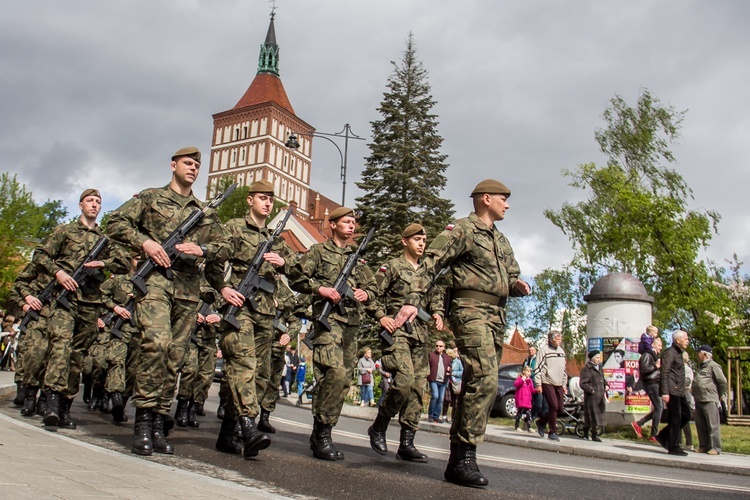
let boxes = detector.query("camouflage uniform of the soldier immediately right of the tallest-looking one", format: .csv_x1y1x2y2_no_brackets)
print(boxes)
206,215,297,420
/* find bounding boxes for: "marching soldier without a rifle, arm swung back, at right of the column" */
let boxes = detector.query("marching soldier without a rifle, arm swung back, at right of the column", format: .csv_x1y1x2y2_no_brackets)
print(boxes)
396,180,529,487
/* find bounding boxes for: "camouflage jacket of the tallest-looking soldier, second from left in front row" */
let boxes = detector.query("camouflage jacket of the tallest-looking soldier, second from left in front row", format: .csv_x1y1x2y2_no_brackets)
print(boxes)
107,185,229,302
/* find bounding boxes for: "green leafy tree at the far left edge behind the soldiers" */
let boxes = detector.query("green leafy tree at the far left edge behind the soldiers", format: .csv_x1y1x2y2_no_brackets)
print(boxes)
0,173,67,306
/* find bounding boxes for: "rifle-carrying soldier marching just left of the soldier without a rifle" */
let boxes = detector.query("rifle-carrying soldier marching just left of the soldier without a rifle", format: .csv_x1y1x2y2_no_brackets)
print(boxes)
367,224,443,462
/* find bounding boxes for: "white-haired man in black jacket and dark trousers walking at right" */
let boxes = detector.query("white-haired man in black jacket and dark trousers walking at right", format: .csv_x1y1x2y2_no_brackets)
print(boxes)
656,330,690,456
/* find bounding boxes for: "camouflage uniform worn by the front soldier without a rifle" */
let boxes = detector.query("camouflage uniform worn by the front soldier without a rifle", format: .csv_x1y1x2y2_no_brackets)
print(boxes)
405,213,520,446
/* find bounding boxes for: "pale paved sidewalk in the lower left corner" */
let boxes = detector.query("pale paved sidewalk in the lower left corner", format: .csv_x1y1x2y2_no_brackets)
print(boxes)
0,372,288,500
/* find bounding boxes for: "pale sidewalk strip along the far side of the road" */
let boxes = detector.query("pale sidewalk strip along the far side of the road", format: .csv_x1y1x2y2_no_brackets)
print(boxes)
288,394,750,476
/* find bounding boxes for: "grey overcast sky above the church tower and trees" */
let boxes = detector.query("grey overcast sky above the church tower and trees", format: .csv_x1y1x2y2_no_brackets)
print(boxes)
0,0,750,277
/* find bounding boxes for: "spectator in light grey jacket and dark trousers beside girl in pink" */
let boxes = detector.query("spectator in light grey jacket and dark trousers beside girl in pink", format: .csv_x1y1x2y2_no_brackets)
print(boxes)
534,330,568,441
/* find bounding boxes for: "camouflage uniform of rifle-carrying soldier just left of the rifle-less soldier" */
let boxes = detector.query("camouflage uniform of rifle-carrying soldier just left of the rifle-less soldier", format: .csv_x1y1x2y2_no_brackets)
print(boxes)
376,255,444,431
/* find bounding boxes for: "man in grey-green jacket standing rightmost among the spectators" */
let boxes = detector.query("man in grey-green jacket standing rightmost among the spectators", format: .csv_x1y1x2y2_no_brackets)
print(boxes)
693,344,727,455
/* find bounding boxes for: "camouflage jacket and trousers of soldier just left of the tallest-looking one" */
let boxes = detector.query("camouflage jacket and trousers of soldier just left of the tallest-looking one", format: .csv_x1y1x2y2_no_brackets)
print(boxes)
34,220,127,399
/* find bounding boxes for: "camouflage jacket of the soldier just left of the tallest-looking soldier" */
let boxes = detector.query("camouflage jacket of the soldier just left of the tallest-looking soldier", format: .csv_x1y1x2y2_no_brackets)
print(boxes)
32,219,130,303
